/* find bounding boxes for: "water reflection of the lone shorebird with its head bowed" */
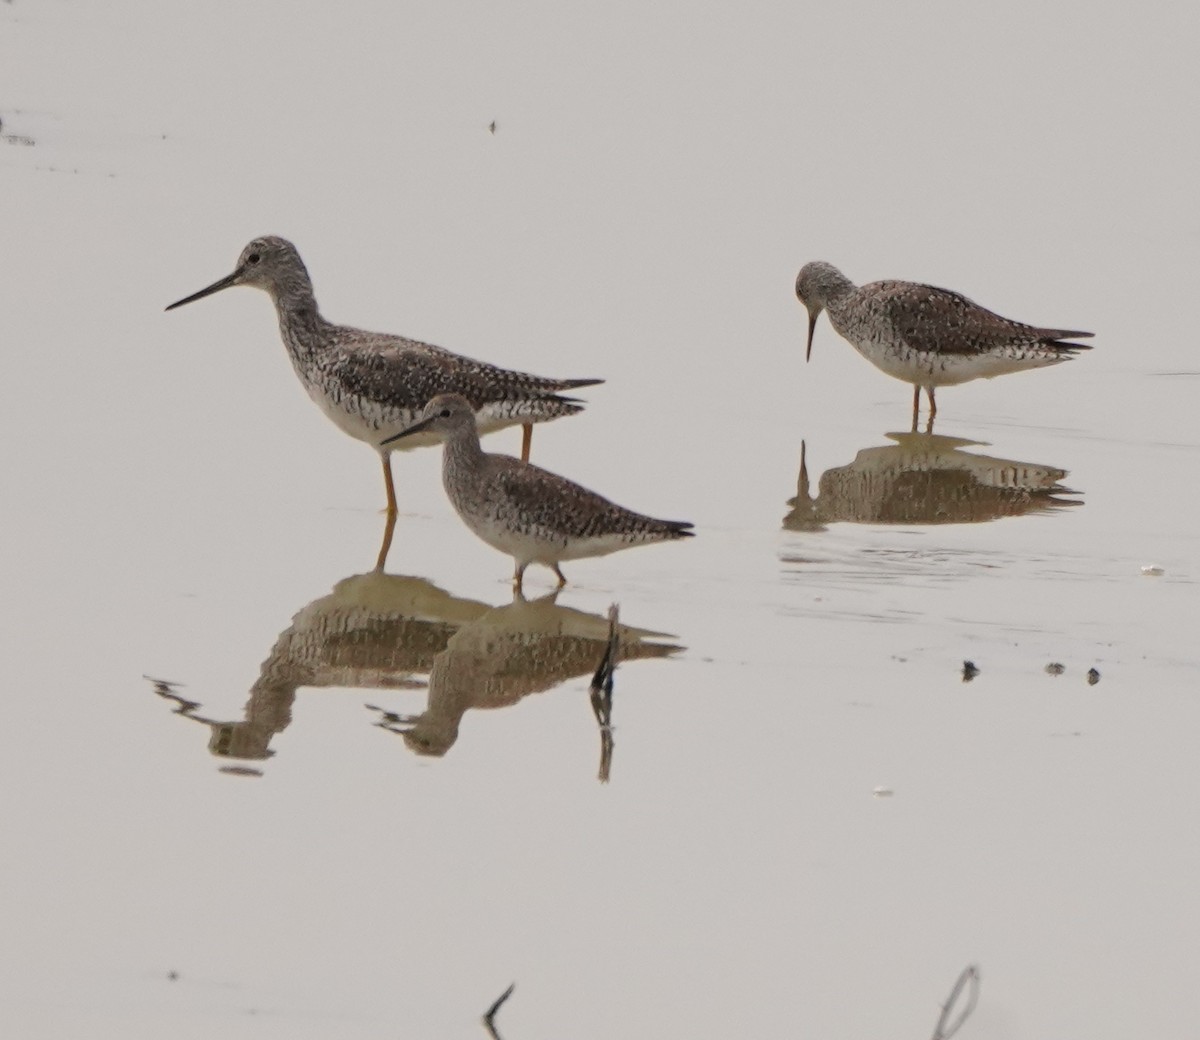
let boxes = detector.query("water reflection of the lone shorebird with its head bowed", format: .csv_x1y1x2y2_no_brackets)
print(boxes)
784,433,1082,531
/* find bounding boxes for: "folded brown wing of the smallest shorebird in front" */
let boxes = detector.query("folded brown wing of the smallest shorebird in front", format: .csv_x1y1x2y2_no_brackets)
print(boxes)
488,455,691,540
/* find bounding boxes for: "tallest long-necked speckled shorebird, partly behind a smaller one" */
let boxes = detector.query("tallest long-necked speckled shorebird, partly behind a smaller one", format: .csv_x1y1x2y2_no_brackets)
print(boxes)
167,235,604,516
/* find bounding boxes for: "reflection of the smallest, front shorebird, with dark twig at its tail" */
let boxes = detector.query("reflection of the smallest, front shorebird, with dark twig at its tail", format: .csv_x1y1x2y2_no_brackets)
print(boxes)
373,590,682,782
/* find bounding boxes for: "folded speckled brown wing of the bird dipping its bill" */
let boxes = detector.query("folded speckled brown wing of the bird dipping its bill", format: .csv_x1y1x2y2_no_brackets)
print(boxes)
860,282,1092,356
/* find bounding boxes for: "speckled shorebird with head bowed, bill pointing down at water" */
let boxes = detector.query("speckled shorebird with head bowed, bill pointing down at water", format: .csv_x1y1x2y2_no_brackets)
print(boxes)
796,260,1092,428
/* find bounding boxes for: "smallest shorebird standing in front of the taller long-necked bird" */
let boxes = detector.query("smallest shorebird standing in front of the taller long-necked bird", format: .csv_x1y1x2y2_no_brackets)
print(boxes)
384,393,691,589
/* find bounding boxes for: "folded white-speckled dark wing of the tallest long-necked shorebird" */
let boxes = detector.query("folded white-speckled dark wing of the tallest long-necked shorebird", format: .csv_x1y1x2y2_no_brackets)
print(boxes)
326,326,604,409
